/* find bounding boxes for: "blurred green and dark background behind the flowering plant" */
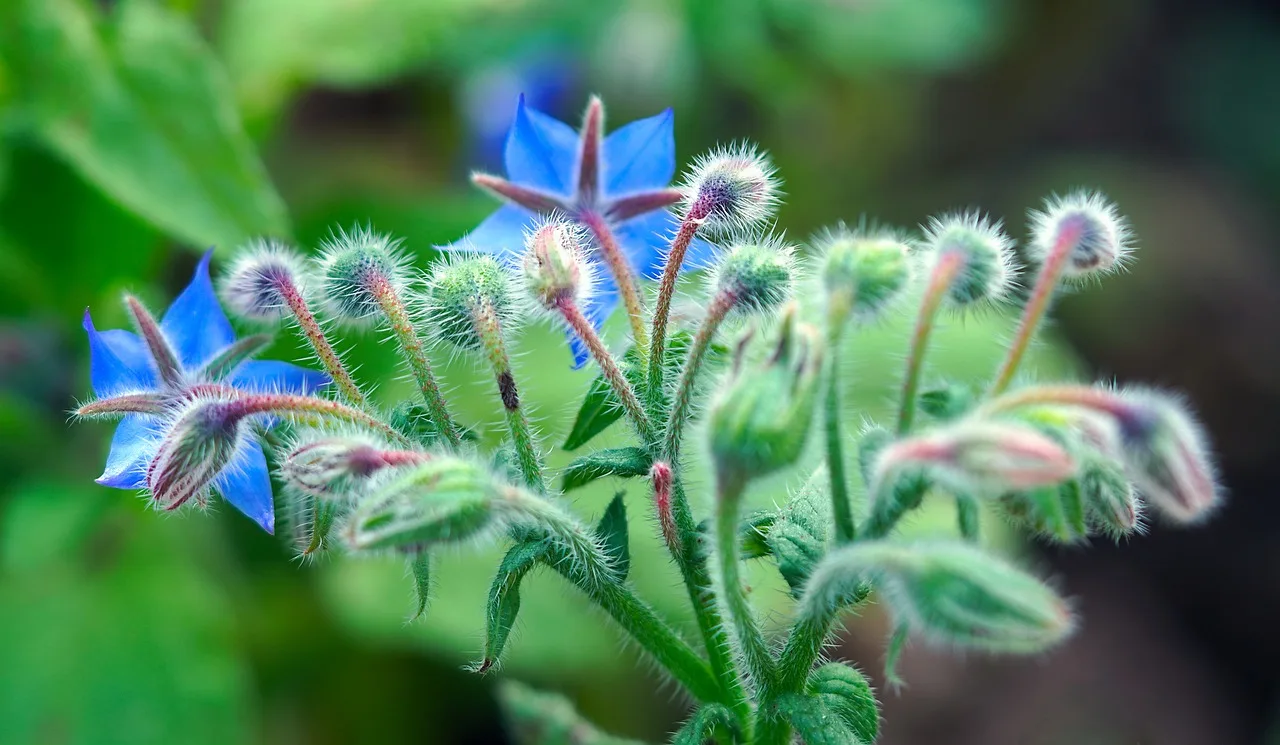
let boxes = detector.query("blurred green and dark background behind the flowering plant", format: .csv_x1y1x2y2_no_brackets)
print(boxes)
0,0,1280,745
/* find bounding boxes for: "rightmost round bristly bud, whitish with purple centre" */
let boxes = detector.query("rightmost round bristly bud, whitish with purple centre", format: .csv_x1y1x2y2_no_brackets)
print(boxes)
1028,192,1133,278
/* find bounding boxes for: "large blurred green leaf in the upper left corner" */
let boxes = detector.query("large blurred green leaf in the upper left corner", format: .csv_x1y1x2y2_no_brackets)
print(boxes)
0,0,289,247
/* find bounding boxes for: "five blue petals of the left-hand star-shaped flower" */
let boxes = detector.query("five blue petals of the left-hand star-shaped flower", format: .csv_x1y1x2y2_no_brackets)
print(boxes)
84,251,329,533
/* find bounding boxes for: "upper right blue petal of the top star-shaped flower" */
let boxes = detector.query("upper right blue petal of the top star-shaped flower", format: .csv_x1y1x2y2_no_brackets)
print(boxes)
604,109,676,195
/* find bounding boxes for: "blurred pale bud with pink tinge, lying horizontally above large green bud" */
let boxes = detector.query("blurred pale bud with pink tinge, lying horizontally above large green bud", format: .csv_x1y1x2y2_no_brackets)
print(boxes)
872,420,1075,497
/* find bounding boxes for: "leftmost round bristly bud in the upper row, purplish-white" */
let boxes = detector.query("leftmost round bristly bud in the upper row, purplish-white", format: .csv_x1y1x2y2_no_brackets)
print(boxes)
223,239,305,320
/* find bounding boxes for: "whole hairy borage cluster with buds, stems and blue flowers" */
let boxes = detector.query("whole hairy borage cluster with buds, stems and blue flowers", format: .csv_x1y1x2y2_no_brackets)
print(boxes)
78,100,1221,744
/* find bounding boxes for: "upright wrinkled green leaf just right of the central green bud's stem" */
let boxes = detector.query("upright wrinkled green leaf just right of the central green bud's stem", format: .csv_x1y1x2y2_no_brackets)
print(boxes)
765,466,832,598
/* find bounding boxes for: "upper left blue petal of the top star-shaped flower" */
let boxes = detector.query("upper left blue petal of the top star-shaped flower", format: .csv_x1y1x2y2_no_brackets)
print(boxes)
504,96,579,196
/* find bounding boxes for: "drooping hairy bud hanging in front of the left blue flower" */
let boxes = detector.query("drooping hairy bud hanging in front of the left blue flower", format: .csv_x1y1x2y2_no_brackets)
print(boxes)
146,398,243,509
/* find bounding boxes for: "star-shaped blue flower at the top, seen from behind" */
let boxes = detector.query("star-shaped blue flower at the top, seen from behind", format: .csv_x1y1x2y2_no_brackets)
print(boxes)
442,96,710,367
